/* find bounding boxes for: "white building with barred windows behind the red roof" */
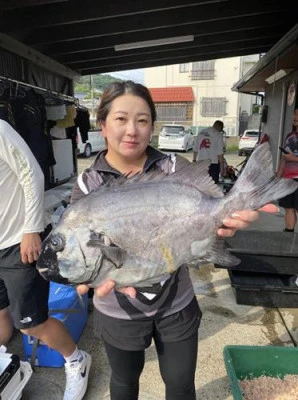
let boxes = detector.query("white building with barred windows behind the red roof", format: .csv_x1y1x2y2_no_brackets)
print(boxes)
144,54,260,136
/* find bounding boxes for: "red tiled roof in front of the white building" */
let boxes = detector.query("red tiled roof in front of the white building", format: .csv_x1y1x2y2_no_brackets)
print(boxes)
149,86,194,103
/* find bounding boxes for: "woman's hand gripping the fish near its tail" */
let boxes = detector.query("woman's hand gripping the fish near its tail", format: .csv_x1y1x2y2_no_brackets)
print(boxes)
217,204,279,237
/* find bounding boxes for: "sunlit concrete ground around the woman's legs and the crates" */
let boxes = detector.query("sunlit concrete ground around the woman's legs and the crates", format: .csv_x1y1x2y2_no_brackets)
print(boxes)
8,152,298,400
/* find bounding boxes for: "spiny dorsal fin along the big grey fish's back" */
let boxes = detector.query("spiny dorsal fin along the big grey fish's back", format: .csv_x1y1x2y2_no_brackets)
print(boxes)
103,161,224,198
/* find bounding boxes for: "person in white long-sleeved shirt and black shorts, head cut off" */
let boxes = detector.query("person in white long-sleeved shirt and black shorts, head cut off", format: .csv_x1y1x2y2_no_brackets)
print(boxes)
0,120,91,400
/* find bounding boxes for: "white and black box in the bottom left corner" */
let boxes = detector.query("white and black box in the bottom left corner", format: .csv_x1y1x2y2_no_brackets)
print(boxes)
0,351,32,400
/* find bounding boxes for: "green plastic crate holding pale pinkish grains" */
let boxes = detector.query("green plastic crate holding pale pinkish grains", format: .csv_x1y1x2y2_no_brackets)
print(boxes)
223,345,298,400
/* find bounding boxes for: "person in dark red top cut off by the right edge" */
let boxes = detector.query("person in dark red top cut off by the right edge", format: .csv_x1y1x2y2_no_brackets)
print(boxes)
277,107,298,232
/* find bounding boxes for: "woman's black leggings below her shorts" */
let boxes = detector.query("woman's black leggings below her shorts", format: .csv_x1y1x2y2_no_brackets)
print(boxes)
104,333,198,400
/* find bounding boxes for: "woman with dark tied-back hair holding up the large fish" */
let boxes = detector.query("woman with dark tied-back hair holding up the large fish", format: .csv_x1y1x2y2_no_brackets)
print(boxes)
71,81,276,400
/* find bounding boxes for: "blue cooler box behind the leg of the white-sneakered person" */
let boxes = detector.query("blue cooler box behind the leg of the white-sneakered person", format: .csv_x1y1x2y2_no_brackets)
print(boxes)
23,282,88,367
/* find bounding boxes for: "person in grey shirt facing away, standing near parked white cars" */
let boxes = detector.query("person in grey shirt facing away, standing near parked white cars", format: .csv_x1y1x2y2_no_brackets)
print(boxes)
193,120,225,183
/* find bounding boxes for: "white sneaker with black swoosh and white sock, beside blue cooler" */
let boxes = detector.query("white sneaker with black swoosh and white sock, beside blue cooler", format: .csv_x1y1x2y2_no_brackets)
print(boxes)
63,350,91,400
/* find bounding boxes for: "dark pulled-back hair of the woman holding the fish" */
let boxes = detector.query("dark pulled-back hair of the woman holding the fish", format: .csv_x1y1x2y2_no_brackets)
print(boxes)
96,81,156,124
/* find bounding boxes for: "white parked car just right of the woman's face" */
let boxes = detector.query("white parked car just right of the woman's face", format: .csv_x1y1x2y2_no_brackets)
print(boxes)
158,124,194,152
